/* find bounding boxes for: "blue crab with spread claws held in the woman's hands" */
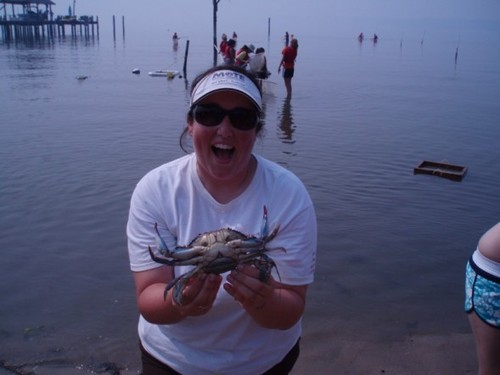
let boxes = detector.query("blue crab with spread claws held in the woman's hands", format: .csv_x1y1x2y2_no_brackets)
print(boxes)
148,206,285,305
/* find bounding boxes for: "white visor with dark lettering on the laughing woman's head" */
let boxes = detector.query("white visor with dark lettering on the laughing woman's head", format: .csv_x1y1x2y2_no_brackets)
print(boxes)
190,70,262,111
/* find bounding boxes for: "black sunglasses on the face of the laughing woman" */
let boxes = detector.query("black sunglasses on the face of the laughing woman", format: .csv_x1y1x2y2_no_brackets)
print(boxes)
191,104,260,130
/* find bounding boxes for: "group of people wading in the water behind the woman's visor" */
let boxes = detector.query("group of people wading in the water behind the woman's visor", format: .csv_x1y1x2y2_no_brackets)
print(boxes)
219,32,299,98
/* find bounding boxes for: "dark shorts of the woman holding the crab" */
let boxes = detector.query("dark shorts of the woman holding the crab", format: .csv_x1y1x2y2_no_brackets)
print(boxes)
141,338,300,375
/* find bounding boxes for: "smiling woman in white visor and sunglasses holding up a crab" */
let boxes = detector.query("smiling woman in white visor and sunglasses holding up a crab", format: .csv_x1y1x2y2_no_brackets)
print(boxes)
127,66,317,375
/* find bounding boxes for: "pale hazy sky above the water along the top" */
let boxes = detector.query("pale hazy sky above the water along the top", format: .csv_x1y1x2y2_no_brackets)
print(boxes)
53,0,500,41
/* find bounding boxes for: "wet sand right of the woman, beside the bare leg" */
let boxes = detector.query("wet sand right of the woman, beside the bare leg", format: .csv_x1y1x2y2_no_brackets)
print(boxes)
293,334,476,375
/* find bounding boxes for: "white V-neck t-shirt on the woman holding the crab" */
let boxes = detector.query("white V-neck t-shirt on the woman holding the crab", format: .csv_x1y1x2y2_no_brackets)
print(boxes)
127,154,317,375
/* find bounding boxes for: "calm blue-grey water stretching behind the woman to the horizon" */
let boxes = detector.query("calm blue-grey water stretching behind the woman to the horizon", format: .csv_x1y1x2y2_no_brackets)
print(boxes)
0,22,500,371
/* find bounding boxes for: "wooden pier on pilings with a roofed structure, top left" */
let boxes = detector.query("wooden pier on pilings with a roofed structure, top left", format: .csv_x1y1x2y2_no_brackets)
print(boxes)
0,0,99,42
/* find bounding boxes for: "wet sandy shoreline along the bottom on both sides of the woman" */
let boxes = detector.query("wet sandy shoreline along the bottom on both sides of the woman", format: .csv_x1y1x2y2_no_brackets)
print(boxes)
0,332,477,375
